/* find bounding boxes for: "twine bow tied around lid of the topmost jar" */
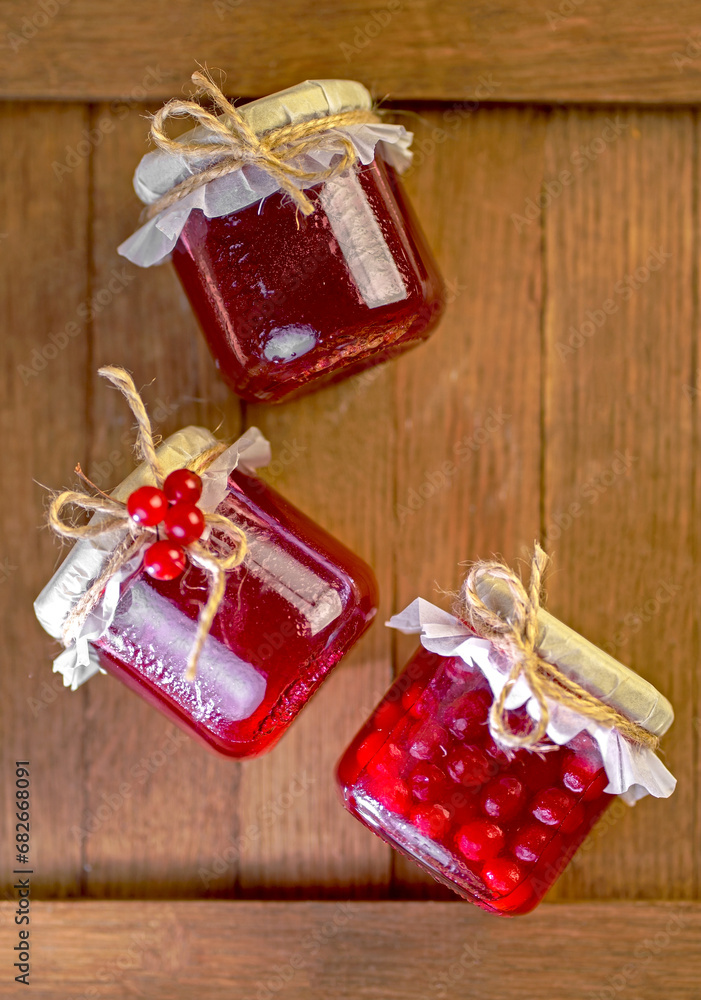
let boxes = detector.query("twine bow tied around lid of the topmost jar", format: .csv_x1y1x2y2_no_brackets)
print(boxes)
146,70,380,219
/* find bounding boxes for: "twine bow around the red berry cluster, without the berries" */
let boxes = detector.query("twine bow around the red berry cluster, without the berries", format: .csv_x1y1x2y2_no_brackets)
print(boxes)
47,365,247,681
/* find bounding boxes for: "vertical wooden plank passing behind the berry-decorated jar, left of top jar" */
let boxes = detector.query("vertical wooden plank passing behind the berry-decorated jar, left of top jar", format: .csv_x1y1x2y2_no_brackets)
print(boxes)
83,106,246,897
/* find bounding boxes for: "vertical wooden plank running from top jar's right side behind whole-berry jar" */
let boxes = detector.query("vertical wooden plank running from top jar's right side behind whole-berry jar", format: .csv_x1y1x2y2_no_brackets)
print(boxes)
395,108,546,898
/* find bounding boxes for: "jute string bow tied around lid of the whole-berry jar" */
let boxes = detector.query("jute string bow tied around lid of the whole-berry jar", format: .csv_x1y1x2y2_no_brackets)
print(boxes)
456,543,659,750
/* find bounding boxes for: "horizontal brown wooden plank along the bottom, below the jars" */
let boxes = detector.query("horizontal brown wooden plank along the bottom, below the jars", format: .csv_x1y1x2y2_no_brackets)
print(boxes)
0,901,701,1000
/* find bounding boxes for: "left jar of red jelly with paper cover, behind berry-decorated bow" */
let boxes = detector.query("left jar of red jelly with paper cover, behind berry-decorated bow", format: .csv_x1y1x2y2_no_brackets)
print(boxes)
35,427,377,758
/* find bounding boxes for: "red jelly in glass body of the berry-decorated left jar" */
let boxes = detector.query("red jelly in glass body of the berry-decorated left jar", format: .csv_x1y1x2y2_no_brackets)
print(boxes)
95,470,377,757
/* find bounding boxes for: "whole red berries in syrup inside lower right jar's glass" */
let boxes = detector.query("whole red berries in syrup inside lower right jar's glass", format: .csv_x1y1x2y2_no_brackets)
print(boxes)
337,648,615,916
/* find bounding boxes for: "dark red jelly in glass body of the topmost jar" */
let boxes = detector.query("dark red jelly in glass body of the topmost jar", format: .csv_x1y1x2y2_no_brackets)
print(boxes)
173,157,444,402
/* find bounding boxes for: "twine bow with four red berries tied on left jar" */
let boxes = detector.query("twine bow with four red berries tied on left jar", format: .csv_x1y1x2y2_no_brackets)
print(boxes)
47,366,247,680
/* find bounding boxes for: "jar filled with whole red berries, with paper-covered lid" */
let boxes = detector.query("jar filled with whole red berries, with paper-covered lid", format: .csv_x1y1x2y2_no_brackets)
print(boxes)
337,594,675,916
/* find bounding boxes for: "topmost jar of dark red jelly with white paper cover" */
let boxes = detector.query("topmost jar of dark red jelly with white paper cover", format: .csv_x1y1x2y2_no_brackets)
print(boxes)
119,80,444,403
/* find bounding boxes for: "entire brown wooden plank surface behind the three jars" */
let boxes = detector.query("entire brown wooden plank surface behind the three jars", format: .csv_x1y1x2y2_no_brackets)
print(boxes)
0,0,701,998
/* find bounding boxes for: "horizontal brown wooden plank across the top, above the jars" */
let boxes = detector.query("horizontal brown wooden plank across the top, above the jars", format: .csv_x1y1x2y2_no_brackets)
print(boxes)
0,0,701,104
